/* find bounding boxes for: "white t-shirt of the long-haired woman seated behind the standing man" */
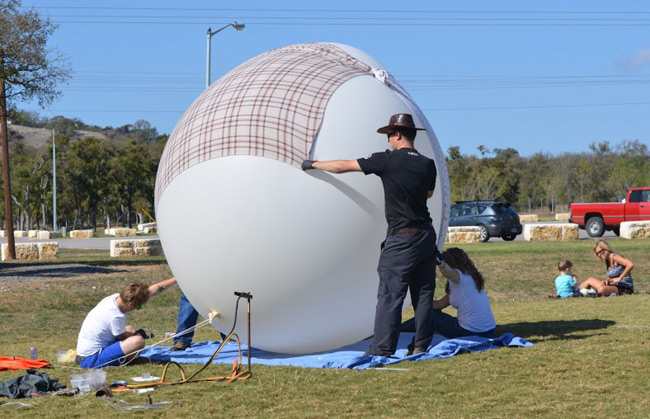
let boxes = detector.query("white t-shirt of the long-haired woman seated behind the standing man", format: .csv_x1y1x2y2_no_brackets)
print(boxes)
449,270,496,332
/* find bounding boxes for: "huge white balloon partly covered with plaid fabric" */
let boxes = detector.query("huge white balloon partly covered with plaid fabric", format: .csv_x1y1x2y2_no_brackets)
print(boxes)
156,43,449,353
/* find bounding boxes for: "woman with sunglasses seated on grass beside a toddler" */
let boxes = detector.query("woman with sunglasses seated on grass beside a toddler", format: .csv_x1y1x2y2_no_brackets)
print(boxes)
580,240,634,297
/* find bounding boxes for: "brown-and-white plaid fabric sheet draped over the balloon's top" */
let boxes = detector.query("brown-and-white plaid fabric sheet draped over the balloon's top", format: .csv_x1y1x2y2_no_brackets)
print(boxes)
156,43,372,207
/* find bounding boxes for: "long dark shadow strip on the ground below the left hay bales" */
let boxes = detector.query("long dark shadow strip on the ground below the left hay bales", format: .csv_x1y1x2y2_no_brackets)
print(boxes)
0,263,123,282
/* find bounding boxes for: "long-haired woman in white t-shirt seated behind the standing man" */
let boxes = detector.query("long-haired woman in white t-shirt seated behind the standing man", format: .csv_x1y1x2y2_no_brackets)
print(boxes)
401,247,496,339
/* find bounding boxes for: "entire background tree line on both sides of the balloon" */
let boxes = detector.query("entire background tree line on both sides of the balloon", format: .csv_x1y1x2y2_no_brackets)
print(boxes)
0,112,650,230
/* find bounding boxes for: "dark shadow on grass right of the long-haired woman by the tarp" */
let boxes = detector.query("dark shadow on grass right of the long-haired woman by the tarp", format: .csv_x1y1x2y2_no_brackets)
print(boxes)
495,319,616,343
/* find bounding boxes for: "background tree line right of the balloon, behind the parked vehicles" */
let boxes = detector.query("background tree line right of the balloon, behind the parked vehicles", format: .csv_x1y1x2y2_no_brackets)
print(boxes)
446,140,650,212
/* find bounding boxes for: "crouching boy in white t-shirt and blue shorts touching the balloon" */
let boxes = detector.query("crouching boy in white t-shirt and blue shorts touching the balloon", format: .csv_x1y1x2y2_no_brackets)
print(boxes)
76,278,176,368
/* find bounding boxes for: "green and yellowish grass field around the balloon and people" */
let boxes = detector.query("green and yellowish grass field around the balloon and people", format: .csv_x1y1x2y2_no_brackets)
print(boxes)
0,239,650,418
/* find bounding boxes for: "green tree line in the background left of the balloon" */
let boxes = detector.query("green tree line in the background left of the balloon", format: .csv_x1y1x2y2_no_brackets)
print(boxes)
0,112,167,230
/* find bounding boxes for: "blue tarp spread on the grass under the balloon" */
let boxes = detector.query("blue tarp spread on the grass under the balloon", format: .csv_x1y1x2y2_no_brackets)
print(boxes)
140,333,533,370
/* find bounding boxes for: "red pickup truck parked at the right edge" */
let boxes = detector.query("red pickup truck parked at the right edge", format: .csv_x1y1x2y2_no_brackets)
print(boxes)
569,187,650,237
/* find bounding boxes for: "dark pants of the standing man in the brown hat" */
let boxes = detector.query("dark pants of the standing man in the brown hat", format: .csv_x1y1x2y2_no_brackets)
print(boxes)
368,230,438,356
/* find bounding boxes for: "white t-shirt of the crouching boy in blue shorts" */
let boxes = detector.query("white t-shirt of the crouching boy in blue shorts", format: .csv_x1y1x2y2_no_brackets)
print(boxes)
77,294,126,356
